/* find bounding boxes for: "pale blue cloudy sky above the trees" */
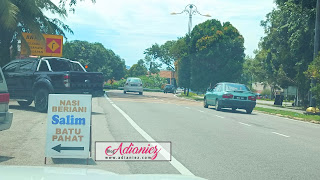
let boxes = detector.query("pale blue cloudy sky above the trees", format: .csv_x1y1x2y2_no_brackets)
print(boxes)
53,0,275,66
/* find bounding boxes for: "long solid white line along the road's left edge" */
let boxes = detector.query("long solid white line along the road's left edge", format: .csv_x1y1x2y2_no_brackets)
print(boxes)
104,94,194,176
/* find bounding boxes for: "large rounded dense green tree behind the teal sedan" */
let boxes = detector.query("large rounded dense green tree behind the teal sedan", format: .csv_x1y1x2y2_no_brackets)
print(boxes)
187,19,244,91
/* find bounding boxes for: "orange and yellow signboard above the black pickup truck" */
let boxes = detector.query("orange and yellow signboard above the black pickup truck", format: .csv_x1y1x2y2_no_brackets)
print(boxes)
21,33,63,57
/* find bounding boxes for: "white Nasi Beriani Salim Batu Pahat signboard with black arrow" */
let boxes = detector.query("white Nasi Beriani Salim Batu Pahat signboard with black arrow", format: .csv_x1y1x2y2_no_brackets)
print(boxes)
45,94,92,159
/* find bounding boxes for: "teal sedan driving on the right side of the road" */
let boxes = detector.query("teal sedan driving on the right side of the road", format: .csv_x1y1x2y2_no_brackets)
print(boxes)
204,82,256,114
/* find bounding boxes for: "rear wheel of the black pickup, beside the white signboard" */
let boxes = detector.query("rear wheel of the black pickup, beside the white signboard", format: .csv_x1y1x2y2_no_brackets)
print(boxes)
34,89,49,112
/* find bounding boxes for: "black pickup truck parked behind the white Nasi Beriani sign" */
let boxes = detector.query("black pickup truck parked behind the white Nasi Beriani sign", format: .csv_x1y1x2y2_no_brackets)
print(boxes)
2,57,104,112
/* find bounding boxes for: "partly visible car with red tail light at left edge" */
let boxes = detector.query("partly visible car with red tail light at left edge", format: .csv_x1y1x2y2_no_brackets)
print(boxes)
0,69,13,131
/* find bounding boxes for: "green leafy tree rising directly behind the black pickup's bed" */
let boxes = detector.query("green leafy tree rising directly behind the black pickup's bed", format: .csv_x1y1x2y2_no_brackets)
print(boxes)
63,40,125,80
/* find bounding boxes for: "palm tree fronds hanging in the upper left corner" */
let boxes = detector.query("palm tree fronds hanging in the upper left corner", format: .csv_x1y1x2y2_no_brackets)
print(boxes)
0,0,72,66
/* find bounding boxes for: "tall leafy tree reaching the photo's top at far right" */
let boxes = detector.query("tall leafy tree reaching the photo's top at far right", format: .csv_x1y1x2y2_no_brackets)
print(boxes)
260,0,316,104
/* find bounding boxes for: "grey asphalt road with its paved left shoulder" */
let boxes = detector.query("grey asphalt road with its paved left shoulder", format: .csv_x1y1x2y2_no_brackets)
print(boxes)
0,91,320,179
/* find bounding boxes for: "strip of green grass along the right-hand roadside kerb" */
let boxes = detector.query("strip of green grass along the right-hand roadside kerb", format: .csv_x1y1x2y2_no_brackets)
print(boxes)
254,107,320,123
